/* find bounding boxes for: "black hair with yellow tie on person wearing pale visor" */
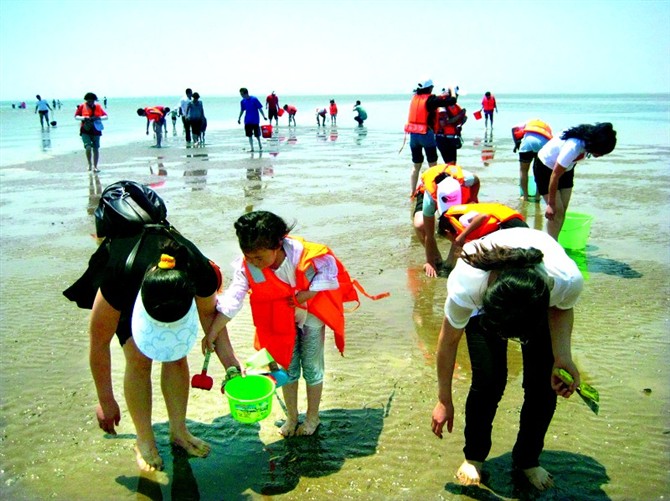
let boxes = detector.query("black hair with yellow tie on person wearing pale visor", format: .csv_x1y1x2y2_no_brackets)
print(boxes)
141,240,195,322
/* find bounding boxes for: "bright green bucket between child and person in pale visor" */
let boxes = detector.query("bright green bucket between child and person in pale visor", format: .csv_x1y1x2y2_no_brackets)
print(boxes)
226,374,275,423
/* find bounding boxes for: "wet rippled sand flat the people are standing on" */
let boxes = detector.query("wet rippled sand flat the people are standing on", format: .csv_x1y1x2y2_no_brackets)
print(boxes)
0,127,670,500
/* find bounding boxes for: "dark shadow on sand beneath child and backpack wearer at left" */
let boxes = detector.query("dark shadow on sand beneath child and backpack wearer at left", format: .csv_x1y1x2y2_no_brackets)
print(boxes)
116,404,392,500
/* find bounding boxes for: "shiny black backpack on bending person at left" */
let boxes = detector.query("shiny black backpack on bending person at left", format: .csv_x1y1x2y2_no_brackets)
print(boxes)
95,180,168,238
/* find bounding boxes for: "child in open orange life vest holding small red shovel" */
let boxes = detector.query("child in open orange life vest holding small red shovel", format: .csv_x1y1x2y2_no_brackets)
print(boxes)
202,211,342,437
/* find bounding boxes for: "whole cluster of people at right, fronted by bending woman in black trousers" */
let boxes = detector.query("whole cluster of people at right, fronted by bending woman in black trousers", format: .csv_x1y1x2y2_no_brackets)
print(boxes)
405,79,616,490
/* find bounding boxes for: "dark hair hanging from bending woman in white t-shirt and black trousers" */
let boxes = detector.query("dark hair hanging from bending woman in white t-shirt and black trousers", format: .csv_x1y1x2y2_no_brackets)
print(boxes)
461,244,551,341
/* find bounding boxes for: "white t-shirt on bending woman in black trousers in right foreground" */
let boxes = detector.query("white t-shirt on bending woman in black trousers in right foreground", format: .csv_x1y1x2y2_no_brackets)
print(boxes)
444,228,584,329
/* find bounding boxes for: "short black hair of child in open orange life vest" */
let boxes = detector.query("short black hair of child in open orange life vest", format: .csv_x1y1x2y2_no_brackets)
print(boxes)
234,210,295,253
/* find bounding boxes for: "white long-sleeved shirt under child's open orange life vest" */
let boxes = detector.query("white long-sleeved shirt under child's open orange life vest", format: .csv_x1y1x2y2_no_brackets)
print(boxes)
216,237,340,327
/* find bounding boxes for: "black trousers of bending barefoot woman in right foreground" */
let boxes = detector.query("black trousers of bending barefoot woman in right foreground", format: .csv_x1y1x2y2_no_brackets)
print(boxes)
463,316,556,469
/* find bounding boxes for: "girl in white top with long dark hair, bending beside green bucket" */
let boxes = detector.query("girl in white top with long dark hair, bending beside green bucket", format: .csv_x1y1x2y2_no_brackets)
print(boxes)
533,122,616,240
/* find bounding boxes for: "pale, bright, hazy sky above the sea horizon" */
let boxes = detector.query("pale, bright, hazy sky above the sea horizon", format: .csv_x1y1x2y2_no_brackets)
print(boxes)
0,0,670,101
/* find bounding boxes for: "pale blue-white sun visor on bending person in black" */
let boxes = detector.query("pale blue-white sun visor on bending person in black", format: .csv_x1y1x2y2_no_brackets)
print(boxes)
131,292,198,362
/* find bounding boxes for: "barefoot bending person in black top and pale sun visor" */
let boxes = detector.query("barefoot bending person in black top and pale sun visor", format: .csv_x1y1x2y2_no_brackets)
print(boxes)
89,229,239,471
